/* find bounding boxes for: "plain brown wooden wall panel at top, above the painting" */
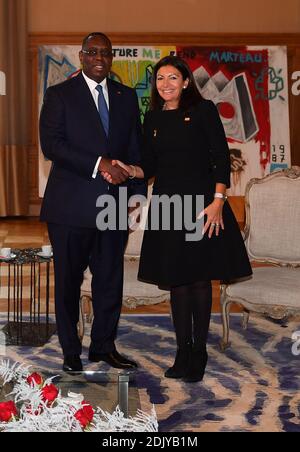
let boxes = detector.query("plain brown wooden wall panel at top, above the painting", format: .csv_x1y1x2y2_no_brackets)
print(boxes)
27,0,300,34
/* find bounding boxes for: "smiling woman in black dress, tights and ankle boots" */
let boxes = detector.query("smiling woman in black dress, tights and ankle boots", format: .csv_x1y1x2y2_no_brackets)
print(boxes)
104,56,252,382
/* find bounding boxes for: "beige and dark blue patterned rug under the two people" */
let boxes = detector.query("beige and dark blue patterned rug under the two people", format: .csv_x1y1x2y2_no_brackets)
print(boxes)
0,315,300,432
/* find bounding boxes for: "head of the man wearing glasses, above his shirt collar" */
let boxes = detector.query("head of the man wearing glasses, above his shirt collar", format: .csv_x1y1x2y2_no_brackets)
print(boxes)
79,36,113,83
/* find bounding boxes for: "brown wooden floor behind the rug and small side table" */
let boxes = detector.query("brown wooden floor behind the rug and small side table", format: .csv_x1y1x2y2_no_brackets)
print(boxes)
0,218,241,314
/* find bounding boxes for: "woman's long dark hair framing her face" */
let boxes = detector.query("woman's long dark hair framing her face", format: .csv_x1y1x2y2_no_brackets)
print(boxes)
150,55,203,111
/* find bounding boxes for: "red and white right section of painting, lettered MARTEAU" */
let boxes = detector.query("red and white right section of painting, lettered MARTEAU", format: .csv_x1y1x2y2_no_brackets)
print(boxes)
176,46,291,196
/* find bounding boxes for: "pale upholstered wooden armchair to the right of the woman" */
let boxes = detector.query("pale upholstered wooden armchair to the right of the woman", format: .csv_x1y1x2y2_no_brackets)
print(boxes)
221,167,300,350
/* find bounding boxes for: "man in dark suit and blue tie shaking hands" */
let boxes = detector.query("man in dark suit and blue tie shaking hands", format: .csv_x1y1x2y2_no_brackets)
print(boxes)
40,33,146,371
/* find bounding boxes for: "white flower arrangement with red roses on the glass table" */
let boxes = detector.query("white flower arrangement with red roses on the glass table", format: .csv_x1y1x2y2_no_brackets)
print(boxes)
0,360,158,432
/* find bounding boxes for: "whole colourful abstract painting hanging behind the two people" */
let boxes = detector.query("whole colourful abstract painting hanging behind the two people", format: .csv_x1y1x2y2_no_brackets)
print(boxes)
38,45,291,196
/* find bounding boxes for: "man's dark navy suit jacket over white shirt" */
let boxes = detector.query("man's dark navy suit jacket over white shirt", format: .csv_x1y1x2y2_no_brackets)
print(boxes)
40,73,146,227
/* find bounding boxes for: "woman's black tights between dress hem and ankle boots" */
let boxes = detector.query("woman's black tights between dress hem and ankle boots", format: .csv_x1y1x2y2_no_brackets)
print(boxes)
171,281,212,348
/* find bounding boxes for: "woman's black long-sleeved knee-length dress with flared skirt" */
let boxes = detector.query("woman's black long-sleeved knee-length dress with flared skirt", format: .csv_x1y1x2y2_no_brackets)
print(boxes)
138,100,252,287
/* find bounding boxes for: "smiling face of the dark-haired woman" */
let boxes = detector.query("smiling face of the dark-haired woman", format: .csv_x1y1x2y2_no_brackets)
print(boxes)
156,66,189,106
